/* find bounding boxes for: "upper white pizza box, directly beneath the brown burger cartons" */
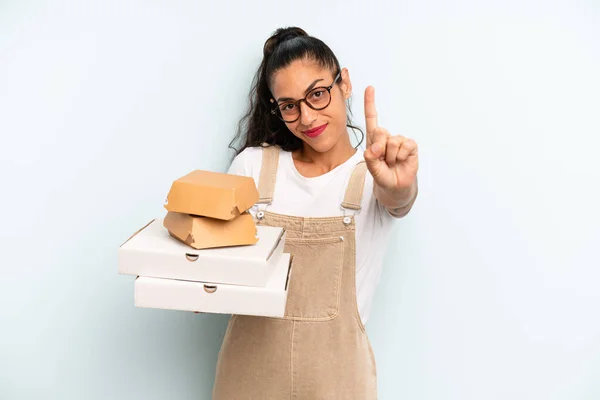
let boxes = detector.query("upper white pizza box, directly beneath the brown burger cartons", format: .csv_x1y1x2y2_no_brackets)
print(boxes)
118,219,286,286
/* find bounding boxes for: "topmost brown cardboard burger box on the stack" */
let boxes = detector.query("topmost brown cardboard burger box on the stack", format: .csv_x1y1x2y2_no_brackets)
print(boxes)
165,170,258,221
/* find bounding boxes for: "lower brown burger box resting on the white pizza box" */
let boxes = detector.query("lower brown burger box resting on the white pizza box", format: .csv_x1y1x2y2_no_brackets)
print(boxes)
163,211,258,249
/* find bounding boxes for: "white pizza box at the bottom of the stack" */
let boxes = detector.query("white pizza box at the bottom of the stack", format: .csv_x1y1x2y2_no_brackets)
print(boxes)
134,254,293,318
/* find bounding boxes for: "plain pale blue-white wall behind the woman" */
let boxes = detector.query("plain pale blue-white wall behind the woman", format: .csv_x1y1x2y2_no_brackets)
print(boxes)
0,0,600,400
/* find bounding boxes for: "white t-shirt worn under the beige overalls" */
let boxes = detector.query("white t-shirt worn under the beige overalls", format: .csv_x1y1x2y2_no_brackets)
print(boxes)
228,147,396,324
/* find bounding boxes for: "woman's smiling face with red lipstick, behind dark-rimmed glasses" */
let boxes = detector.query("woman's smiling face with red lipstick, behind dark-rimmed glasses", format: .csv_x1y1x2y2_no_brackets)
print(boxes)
271,59,352,153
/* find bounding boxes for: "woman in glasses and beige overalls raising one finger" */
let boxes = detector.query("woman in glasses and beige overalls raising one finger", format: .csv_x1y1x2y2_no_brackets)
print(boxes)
213,28,418,400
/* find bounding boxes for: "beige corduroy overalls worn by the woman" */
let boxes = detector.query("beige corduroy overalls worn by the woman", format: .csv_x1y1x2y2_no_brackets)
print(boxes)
213,147,377,400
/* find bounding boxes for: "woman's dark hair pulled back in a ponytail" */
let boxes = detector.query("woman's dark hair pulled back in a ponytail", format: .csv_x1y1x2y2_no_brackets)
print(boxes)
229,27,365,155
